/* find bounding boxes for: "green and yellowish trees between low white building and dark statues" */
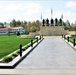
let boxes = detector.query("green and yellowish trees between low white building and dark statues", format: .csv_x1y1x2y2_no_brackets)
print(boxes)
10,19,41,33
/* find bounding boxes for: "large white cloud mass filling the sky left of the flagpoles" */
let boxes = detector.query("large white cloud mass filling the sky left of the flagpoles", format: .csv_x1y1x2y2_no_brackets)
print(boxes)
0,2,41,21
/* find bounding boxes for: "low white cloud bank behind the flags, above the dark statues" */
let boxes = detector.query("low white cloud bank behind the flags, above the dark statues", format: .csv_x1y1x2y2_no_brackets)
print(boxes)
45,9,76,23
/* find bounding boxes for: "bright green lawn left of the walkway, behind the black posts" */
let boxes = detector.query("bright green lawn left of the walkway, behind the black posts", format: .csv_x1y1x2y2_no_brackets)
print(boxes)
0,35,34,59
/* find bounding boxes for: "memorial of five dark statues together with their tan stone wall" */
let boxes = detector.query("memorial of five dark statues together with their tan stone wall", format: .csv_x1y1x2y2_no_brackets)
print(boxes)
40,18,67,36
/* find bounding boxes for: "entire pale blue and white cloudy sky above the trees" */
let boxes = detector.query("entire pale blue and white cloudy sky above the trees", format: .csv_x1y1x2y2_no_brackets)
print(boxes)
0,0,76,23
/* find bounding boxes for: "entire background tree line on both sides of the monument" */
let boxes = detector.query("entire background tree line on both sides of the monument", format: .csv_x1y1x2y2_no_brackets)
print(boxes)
0,19,76,33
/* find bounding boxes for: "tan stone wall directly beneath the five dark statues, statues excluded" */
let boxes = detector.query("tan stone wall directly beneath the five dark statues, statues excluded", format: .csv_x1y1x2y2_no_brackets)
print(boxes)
40,26,67,36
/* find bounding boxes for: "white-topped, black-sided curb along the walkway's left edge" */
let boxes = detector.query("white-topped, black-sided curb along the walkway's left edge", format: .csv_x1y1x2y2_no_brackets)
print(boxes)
0,38,44,69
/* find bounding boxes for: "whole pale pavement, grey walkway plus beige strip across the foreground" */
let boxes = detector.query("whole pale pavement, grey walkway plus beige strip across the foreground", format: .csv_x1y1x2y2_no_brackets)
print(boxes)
0,37,76,75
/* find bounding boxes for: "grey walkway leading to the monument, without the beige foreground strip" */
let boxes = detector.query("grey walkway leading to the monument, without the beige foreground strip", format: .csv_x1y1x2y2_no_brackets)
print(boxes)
16,38,76,69
